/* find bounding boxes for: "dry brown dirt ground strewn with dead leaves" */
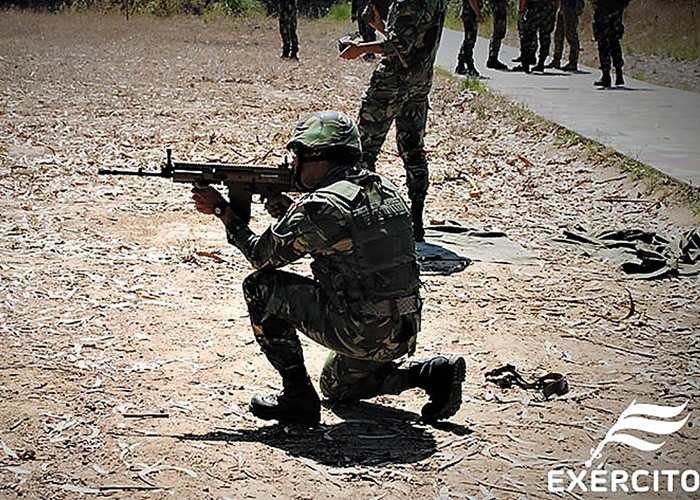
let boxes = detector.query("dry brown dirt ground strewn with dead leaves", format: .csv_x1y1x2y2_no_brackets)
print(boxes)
0,12,700,499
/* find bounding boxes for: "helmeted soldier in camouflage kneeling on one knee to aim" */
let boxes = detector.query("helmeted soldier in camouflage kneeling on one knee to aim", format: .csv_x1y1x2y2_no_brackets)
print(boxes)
192,111,465,425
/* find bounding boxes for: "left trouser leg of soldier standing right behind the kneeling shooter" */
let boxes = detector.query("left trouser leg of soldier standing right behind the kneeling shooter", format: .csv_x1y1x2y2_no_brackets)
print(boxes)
357,78,399,171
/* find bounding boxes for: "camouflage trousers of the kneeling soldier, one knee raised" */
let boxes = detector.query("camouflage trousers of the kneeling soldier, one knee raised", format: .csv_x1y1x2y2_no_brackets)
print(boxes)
243,270,420,401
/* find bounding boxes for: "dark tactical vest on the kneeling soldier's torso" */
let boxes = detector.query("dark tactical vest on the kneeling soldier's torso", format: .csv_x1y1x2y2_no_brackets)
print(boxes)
311,173,420,314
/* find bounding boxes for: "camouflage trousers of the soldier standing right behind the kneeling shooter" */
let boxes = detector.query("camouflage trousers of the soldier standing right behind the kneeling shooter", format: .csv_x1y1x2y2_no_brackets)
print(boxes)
358,70,432,201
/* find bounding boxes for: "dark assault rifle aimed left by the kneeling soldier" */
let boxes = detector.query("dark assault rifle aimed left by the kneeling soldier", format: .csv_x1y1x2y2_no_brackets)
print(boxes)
97,149,303,222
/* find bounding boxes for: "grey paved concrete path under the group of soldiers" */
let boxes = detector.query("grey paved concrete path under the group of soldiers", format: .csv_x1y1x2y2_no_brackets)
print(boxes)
436,29,700,187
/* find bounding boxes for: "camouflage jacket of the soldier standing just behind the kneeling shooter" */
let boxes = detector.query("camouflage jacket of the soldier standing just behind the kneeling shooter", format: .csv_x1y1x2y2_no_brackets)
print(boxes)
378,0,447,80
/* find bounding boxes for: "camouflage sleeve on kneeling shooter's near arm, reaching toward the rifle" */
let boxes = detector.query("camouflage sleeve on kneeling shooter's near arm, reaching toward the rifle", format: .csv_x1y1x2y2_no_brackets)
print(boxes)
227,197,345,269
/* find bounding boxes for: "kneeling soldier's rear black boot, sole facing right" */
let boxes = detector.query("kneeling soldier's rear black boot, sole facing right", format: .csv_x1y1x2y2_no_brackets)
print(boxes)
408,356,466,422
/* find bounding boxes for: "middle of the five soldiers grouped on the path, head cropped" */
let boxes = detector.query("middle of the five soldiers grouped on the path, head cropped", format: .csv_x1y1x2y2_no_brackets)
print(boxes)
513,0,561,73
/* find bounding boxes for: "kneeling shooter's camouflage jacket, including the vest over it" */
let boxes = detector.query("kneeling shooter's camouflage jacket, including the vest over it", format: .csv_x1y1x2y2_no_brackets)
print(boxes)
227,168,419,313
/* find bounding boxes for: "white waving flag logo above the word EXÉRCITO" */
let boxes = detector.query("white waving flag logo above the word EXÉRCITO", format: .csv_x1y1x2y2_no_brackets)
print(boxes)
586,400,689,467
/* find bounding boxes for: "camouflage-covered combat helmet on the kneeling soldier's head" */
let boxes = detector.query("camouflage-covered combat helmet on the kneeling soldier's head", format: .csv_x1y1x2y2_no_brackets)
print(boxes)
287,111,362,156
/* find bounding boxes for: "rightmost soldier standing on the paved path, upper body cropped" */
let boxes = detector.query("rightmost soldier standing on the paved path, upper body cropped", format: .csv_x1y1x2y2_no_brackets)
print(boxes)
592,0,629,88
